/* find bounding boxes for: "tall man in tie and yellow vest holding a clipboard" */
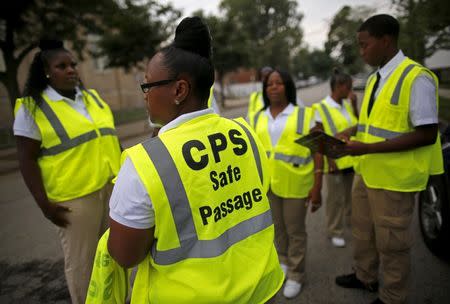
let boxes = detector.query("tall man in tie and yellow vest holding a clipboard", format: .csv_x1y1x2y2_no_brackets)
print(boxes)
336,14,443,304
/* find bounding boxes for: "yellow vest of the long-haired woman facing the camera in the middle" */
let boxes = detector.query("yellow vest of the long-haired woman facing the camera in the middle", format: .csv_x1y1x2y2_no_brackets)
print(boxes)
250,106,314,198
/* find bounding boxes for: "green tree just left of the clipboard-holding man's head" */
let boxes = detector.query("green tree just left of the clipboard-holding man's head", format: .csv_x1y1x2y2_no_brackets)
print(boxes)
325,5,374,74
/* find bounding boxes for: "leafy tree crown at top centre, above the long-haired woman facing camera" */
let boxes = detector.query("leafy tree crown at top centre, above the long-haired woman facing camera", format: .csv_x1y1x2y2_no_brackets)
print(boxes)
220,0,303,69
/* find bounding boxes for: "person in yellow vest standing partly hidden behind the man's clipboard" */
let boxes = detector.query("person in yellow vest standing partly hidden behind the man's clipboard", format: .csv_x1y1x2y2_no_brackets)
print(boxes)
313,69,358,247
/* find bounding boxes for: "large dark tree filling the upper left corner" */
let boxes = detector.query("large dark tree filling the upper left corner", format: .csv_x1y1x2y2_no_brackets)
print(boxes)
0,0,179,108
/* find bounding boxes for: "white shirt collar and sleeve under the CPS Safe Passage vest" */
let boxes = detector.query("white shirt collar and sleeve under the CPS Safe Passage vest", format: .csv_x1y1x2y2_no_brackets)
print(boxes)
109,108,214,229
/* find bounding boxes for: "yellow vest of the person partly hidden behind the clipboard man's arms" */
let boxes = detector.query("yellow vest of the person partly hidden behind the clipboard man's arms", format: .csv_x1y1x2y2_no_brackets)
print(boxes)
313,99,358,170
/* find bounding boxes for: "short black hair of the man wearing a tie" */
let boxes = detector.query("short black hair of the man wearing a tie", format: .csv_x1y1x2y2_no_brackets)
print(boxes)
358,14,400,40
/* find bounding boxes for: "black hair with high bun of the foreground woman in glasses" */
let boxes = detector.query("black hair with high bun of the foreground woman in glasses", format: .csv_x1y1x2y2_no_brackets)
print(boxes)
160,17,214,105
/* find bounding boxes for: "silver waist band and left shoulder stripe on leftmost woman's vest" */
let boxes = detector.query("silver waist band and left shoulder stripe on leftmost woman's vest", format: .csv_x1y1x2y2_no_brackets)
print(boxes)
38,97,116,156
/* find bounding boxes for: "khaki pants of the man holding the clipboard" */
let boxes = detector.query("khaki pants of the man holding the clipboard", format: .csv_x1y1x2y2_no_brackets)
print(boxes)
352,175,415,304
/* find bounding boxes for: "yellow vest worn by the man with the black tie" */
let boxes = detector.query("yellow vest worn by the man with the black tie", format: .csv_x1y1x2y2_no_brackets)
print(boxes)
355,58,443,192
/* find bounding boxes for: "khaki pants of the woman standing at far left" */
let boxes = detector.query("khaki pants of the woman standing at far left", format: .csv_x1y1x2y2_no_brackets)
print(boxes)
57,183,112,304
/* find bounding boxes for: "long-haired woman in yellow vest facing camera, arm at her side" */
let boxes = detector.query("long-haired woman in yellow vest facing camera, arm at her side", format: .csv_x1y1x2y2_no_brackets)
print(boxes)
250,69,322,298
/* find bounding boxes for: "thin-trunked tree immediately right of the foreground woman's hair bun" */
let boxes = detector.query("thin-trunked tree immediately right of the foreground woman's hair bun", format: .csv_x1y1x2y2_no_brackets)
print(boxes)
194,11,249,106
